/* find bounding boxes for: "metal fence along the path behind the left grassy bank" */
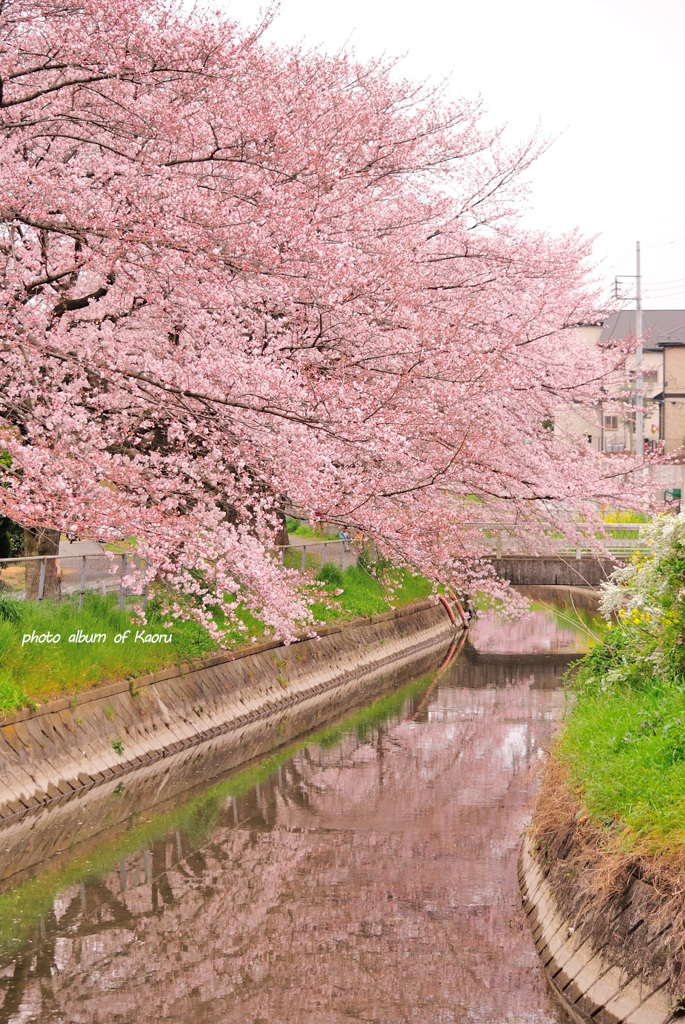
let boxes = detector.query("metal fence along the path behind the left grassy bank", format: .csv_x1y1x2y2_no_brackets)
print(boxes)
0,540,360,608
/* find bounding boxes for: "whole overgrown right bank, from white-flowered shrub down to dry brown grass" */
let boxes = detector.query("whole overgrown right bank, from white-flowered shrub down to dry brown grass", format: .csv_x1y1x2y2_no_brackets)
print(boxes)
532,515,685,1007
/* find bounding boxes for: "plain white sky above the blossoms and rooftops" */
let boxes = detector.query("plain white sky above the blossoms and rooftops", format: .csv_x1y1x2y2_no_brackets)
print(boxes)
222,0,685,309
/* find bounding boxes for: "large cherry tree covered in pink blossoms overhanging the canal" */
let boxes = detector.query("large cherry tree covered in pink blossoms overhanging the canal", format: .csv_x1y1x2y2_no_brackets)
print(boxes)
0,0,651,636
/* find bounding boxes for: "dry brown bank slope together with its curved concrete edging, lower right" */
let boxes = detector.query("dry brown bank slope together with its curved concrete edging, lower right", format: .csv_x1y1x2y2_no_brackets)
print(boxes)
519,761,685,1024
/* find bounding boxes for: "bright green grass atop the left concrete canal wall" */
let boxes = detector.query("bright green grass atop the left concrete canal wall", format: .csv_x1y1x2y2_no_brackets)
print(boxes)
0,563,431,714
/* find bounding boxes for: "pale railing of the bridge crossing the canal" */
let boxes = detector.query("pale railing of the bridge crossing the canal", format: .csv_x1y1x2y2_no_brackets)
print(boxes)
467,522,648,560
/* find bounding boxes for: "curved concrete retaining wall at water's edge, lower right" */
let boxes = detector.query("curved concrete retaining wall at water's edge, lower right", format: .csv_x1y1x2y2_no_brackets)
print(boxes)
519,837,673,1024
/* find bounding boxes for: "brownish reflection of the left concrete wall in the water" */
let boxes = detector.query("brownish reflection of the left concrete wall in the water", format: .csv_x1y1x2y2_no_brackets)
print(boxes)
0,634,448,891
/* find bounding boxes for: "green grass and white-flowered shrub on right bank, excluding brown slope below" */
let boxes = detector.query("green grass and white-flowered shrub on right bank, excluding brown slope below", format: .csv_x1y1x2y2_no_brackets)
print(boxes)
555,513,685,860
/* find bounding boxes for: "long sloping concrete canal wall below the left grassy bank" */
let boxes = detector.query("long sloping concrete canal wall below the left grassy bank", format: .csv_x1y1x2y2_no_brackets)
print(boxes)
0,601,461,820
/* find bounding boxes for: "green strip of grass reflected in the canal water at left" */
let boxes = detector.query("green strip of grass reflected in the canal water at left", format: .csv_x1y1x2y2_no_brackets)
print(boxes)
0,675,433,954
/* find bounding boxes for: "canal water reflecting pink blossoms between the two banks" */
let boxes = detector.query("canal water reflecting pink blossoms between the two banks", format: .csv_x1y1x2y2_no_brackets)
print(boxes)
0,611,583,1024
